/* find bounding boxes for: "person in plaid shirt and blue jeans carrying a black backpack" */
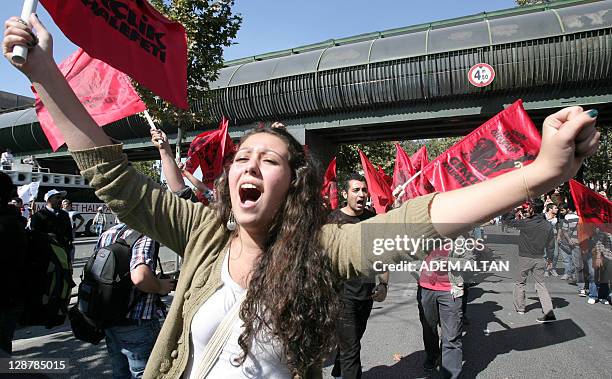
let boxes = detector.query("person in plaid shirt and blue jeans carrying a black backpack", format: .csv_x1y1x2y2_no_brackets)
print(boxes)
94,223,176,378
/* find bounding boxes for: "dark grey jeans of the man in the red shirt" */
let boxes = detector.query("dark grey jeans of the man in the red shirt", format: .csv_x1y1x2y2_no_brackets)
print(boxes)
417,286,463,378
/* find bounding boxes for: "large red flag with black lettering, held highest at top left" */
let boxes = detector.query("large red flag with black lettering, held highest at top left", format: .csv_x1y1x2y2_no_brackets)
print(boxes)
41,0,189,109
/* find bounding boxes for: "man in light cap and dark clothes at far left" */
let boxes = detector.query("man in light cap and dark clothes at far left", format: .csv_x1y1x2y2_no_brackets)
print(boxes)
30,189,73,264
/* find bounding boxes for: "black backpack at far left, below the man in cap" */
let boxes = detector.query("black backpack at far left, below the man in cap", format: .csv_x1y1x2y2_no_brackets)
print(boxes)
21,231,75,329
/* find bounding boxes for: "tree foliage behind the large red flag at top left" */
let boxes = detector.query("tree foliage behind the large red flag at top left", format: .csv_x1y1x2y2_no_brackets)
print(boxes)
136,0,242,125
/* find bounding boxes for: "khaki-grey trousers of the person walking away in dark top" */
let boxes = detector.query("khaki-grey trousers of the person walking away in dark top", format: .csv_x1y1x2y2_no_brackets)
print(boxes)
513,256,553,315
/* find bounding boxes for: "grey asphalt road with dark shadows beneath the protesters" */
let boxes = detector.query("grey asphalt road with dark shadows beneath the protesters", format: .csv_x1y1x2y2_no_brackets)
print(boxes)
5,228,612,379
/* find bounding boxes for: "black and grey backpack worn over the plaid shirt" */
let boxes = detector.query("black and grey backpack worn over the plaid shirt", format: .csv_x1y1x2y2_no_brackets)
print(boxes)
77,226,159,329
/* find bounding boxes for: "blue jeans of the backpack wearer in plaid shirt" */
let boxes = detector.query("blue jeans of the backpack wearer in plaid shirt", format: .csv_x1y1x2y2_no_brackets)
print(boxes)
104,319,160,379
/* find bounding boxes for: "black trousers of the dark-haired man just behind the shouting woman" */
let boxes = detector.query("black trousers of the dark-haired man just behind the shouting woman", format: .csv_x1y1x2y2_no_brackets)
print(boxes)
332,299,372,379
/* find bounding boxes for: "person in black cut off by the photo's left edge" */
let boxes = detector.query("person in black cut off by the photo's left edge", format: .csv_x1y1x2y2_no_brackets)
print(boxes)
0,172,27,355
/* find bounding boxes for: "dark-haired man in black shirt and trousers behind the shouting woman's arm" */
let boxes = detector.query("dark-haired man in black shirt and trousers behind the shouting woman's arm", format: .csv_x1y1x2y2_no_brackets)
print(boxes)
328,174,389,379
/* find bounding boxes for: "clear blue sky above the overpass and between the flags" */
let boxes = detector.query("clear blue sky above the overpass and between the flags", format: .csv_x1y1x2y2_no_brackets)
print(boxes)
0,0,516,96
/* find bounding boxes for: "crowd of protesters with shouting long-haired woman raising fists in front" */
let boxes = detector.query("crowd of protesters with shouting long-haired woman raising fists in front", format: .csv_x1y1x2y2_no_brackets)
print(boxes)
0,10,610,378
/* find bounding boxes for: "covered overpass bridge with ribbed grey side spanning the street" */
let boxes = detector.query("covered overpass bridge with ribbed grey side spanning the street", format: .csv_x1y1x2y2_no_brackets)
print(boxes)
0,0,612,171
